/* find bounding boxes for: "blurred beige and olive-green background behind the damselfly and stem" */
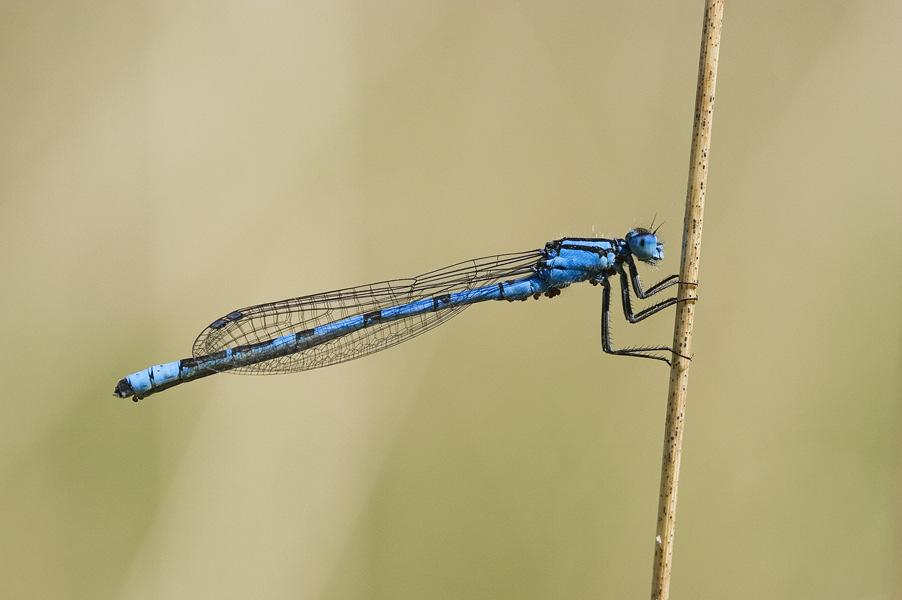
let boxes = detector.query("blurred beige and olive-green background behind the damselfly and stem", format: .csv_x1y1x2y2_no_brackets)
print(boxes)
0,0,902,599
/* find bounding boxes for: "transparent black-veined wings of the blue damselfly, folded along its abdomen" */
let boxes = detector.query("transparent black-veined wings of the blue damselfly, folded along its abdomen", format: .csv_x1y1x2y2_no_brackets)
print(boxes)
193,250,542,375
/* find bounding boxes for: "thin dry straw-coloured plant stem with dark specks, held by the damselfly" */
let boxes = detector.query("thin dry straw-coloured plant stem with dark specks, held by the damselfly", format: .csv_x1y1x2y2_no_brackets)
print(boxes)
651,0,724,600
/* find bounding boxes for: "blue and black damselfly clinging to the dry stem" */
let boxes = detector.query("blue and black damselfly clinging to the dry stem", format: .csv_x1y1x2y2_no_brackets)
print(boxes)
114,228,694,402
